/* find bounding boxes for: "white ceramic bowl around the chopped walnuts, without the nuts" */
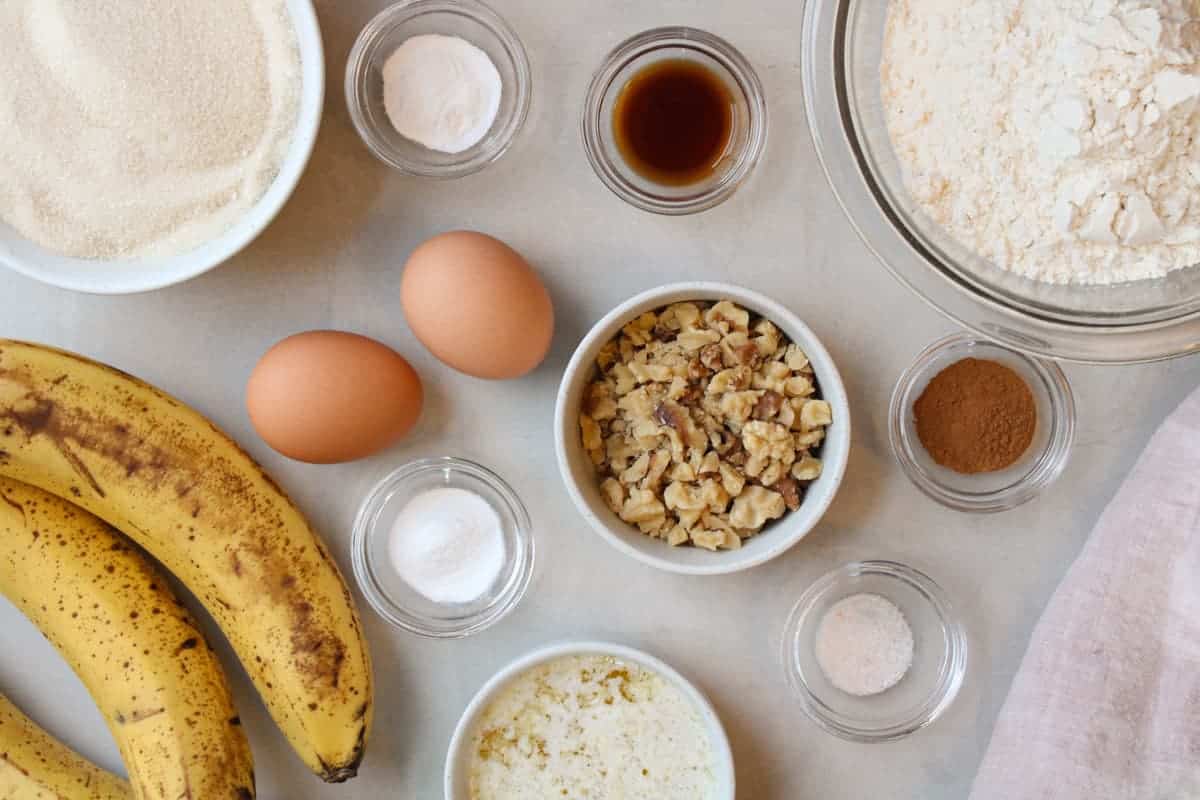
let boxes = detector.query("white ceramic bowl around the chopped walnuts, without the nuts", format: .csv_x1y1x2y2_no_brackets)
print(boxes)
554,283,850,575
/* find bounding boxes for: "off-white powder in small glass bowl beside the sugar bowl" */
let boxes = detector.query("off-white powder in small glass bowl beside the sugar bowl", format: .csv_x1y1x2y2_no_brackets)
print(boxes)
383,34,503,154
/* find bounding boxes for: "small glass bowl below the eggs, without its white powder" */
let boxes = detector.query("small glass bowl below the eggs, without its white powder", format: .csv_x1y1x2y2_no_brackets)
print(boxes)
350,458,534,639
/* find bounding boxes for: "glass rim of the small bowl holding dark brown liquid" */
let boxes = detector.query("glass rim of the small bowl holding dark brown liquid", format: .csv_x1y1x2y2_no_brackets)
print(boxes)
580,25,768,216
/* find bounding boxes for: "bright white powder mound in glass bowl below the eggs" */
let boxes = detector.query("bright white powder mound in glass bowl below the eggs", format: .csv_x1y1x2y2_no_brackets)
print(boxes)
388,488,506,603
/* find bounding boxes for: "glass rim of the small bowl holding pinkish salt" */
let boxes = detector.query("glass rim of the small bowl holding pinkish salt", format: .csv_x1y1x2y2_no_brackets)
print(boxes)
780,559,970,744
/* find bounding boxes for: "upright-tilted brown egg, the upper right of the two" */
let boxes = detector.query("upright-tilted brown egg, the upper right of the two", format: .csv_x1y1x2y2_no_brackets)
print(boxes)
400,230,554,379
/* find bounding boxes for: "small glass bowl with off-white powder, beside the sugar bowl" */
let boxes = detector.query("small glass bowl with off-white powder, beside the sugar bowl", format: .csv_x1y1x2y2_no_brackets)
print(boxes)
346,0,533,179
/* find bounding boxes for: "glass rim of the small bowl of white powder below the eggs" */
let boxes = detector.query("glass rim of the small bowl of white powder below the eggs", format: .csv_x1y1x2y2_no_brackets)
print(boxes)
350,456,536,639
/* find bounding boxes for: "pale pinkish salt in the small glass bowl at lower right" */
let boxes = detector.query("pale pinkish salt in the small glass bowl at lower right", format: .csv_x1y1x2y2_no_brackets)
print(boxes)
816,594,913,697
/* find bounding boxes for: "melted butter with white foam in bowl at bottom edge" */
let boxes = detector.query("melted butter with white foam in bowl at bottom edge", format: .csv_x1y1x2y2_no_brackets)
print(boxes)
469,656,716,800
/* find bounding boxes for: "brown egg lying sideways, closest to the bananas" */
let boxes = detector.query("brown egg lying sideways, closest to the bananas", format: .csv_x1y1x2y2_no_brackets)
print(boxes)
246,331,424,464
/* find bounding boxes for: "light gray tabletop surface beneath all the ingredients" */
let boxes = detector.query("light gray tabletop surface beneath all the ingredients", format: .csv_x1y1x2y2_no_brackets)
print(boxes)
0,0,1200,800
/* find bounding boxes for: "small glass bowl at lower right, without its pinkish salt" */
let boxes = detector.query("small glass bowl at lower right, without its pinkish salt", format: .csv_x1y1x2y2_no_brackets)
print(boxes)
782,561,967,744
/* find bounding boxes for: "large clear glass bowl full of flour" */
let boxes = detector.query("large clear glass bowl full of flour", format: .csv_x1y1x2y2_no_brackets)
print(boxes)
803,0,1200,363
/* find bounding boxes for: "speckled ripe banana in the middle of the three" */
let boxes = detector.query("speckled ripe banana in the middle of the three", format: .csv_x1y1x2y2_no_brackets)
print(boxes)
0,477,254,800
